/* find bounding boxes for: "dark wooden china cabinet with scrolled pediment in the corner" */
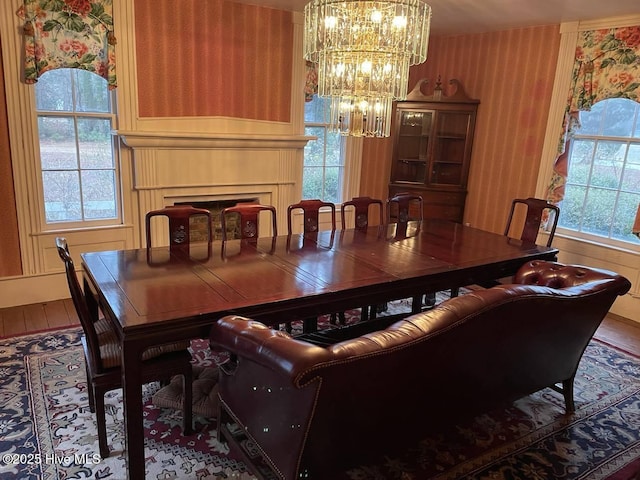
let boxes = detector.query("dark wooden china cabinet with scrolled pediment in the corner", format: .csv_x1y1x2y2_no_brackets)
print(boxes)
389,79,480,223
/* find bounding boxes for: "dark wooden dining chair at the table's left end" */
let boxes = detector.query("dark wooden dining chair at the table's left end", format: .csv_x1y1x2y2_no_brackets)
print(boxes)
56,237,193,458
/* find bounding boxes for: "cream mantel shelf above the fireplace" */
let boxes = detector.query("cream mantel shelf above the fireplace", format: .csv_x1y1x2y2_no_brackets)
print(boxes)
119,130,315,150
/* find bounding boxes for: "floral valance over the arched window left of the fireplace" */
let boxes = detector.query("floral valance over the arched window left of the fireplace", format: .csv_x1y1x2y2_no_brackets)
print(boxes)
17,0,117,89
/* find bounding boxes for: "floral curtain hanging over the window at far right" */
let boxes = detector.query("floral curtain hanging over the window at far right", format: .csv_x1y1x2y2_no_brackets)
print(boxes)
547,26,640,204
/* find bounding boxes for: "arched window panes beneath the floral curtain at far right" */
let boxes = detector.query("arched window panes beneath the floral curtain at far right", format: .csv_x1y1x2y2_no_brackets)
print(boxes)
558,98,640,246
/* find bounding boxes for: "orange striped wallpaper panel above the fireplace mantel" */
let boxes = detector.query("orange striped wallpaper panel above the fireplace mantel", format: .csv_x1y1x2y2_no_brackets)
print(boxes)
135,0,293,122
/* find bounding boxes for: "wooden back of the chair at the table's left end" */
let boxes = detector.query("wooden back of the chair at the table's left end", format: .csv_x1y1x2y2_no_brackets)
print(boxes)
56,237,103,372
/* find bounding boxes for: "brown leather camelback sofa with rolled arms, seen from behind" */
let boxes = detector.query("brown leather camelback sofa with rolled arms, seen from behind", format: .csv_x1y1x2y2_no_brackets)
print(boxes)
210,261,630,479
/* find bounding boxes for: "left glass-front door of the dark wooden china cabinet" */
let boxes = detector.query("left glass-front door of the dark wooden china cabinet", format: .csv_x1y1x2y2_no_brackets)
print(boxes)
395,110,433,183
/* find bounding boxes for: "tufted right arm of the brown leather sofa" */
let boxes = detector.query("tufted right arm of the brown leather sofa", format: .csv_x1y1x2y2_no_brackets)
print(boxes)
513,260,631,295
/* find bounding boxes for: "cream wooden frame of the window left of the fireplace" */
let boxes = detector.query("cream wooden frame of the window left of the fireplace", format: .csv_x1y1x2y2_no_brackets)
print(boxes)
31,72,123,233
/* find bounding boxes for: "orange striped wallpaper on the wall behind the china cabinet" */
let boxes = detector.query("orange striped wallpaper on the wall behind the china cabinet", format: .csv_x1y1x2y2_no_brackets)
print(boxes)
361,25,560,233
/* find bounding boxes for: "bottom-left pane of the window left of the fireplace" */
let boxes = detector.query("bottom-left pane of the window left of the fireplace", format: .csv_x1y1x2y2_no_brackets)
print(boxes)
42,171,82,222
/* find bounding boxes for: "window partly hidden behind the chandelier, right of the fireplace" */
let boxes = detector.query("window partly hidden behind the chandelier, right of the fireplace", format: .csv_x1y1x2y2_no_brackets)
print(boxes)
302,95,345,203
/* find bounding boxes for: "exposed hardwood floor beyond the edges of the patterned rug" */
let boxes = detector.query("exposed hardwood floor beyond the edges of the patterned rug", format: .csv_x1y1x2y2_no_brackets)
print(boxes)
0,298,640,356
